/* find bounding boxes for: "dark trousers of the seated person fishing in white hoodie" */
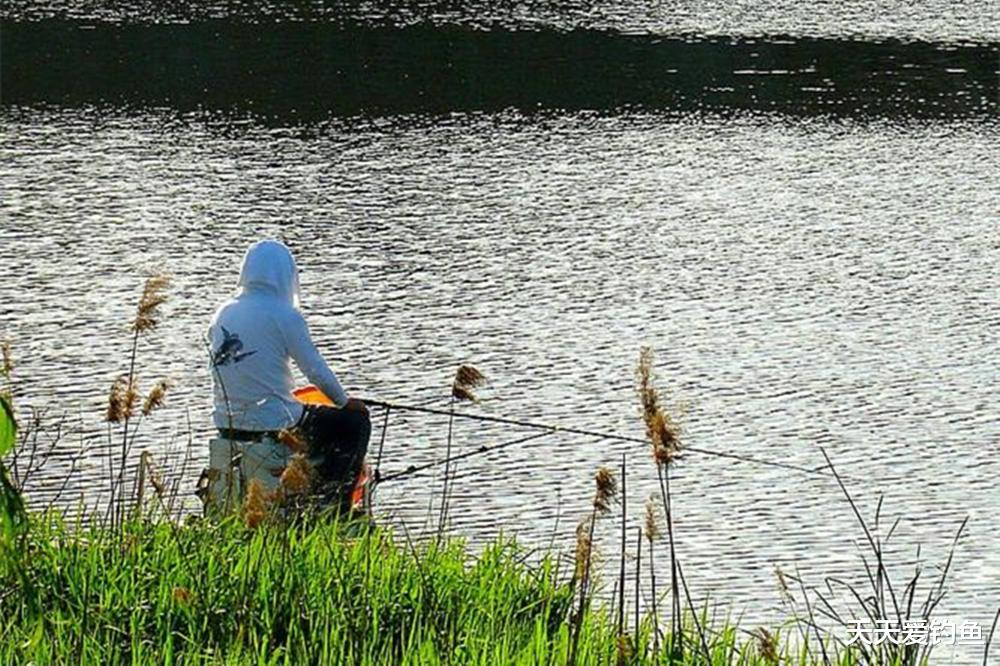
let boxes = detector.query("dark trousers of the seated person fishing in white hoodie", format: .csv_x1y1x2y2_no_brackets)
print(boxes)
299,405,372,510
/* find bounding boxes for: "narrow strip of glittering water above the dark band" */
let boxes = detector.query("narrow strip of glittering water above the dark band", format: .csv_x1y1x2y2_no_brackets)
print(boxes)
3,0,1000,42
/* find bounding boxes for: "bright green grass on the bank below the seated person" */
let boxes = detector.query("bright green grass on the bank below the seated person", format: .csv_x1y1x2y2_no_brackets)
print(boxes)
0,516,847,665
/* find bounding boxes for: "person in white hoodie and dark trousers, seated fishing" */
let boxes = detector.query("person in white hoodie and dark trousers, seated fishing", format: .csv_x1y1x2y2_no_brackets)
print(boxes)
209,241,371,508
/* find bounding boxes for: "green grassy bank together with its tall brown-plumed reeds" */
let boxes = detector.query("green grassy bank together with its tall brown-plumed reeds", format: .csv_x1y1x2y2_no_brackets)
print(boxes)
0,280,992,666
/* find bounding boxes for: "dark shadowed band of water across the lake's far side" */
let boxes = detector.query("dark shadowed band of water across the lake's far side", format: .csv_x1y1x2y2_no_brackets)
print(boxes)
0,20,1000,119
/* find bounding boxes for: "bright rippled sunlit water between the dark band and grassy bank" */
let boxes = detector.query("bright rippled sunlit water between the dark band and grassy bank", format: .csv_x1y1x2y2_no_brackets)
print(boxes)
0,108,1000,660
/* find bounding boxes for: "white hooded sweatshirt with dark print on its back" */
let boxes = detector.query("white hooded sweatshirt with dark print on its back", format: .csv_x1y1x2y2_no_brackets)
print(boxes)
208,240,347,432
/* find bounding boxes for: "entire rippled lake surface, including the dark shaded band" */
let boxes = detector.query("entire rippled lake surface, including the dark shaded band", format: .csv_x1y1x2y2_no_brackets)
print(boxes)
0,2,1000,663
